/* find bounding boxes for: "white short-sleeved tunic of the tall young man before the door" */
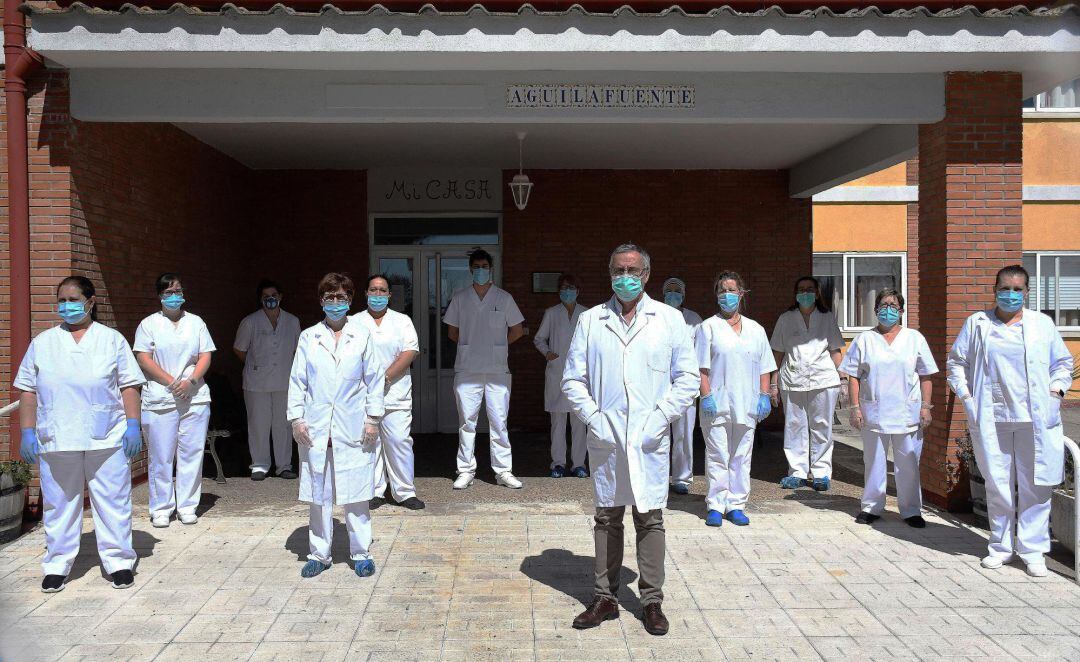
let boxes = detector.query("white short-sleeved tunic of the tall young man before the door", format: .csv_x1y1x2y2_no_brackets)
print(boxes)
443,285,525,374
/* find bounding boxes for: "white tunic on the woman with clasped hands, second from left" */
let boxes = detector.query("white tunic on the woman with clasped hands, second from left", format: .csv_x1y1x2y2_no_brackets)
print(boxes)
133,311,217,411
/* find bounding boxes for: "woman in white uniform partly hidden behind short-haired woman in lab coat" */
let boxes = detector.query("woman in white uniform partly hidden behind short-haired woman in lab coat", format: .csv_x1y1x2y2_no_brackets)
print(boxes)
351,274,424,511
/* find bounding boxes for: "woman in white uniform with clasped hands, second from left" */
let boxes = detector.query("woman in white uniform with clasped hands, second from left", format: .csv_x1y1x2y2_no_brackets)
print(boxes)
135,273,217,528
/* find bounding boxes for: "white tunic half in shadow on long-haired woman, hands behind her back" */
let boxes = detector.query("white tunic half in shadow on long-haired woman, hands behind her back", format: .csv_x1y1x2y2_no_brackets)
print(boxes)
771,308,843,391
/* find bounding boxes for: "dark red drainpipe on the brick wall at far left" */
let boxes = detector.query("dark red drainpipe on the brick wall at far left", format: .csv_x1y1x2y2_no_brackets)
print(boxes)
3,0,44,455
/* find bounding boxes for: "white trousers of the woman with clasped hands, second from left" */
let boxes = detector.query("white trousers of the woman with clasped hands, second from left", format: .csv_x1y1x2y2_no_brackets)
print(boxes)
143,405,210,517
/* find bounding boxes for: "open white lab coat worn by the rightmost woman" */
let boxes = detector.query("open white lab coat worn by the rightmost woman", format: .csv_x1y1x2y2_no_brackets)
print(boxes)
946,310,1072,486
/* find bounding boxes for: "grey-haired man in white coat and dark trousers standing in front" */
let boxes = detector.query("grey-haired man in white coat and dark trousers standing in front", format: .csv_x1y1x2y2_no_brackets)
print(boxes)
563,244,699,635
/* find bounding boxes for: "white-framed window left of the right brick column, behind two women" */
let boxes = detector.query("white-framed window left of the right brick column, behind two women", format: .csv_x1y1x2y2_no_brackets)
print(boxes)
813,253,907,330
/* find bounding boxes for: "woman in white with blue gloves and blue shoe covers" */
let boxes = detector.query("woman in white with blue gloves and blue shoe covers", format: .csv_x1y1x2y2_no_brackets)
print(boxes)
694,271,777,526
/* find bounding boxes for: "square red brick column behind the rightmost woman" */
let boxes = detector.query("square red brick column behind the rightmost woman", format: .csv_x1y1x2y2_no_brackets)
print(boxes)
918,72,1023,510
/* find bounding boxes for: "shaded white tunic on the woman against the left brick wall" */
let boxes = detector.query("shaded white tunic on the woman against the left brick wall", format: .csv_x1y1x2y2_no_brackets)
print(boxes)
232,310,300,393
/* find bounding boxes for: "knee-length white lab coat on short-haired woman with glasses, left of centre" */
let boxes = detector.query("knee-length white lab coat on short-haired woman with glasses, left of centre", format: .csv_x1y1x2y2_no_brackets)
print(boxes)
287,321,386,505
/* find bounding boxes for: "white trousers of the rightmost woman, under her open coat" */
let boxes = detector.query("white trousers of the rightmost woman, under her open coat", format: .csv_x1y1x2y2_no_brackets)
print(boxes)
974,423,1053,563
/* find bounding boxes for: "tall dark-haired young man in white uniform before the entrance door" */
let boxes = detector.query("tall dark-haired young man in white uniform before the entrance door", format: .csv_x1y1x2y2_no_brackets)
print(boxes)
443,249,525,489
